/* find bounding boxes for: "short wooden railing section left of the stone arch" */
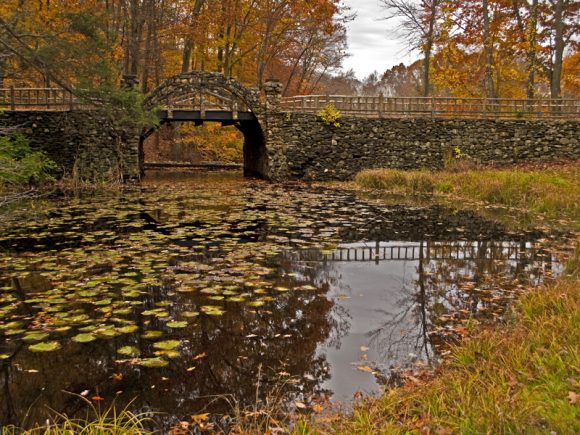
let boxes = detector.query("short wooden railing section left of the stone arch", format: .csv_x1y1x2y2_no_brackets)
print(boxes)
0,87,91,111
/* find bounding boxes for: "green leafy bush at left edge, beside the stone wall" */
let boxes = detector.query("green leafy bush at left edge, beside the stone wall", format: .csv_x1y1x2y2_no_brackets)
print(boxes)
0,135,56,187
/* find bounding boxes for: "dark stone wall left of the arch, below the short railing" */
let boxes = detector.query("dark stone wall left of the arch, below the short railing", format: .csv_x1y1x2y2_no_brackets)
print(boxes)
0,111,140,181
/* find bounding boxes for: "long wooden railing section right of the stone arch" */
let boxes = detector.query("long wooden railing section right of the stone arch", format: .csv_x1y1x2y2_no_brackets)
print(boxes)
281,95,580,119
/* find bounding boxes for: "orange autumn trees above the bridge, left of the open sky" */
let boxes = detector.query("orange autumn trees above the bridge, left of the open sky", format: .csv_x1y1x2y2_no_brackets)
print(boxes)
0,0,348,93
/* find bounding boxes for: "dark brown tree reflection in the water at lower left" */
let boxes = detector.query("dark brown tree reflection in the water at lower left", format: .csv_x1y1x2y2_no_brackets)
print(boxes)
0,255,344,430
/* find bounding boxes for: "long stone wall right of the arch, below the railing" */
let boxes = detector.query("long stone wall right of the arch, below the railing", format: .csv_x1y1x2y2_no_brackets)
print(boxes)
267,113,580,180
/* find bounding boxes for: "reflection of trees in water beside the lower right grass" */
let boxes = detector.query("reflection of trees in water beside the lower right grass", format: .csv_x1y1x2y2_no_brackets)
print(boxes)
369,241,552,370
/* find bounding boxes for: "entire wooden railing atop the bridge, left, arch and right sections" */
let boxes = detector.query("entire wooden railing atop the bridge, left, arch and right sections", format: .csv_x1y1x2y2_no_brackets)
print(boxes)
0,87,580,120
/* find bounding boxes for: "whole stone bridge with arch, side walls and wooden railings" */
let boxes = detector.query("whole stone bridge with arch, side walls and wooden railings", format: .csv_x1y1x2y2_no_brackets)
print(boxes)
0,71,580,181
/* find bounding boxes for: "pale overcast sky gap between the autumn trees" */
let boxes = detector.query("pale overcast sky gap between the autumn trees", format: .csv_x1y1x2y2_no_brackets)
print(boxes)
343,0,417,79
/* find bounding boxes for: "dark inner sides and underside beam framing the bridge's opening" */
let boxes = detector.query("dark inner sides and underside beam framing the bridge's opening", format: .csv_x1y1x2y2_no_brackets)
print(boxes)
139,119,269,179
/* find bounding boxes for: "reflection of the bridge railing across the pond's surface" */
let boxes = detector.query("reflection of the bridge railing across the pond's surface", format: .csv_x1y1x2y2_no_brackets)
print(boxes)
324,241,549,263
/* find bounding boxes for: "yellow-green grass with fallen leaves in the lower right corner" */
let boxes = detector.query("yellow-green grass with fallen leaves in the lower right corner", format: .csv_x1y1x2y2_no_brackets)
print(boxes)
308,249,580,434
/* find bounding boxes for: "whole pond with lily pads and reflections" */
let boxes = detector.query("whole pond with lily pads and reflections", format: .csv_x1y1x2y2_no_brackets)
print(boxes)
0,173,562,428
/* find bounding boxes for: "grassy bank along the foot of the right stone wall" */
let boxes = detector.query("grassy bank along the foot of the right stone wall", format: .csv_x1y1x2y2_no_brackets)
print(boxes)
355,164,580,226
